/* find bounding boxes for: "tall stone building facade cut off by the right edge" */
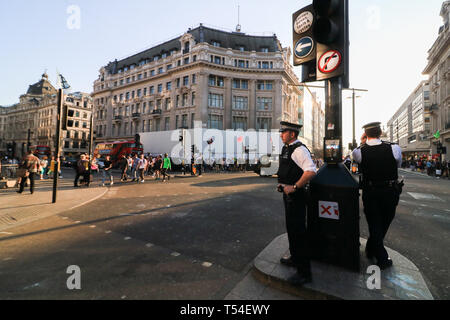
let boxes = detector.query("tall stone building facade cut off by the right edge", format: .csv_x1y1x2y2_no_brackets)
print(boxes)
423,1,450,160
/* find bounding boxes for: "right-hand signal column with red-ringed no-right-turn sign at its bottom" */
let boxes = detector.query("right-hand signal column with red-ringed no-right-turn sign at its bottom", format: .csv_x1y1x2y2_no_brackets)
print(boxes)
312,0,349,88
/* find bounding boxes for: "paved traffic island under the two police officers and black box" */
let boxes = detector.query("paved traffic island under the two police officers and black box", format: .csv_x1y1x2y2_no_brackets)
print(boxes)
229,234,434,300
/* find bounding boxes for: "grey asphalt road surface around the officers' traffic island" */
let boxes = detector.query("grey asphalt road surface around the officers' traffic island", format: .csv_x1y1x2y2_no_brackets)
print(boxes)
0,173,450,299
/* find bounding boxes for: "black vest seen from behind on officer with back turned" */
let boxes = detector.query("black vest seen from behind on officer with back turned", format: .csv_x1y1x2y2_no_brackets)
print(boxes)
361,141,398,183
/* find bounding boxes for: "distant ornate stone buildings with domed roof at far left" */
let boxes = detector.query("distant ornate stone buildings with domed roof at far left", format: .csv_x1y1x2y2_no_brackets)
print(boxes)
0,73,93,158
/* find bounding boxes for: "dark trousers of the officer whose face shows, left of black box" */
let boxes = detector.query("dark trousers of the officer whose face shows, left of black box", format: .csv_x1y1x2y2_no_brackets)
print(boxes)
283,190,311,275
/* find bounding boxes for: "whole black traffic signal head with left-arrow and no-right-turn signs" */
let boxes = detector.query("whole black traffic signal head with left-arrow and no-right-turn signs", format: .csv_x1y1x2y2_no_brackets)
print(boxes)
292,0,349,88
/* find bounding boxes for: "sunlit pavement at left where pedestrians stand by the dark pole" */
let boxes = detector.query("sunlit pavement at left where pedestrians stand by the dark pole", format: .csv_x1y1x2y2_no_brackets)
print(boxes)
0,187,108,232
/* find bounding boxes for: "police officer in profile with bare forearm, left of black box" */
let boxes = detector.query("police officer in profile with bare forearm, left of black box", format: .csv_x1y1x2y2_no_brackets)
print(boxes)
278,121,317,285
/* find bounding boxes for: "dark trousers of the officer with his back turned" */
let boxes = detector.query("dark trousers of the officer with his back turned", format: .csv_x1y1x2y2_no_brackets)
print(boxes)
362,187,399,263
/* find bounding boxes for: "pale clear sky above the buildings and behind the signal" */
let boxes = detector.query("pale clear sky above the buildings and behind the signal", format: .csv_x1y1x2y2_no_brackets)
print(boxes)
0,0,442,144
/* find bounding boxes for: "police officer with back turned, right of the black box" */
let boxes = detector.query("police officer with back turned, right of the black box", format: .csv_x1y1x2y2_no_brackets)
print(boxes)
352,122,403,270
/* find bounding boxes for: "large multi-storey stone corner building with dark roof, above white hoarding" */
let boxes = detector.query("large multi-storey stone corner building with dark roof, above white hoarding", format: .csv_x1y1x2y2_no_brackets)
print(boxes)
92,25,301,146
